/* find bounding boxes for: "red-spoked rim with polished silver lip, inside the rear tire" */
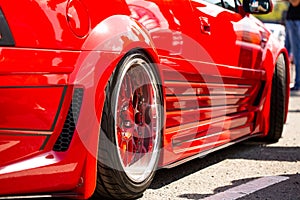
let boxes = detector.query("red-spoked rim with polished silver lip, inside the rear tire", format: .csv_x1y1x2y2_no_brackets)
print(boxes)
114,54,161,182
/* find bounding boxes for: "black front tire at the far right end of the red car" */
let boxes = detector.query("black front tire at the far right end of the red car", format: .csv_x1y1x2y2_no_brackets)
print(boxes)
265,54,287,143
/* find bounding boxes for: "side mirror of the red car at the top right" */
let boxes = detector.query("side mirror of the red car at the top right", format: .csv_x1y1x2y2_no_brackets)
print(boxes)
243,0,273,14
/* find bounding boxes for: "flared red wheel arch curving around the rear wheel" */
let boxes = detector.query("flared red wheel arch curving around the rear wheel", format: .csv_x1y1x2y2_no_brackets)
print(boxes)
70,15,163,198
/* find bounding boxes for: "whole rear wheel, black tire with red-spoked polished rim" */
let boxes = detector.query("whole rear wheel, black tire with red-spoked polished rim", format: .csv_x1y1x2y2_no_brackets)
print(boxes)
95,51,163,199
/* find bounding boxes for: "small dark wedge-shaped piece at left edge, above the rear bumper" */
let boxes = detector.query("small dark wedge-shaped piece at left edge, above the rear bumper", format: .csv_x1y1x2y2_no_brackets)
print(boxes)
0,9,15,46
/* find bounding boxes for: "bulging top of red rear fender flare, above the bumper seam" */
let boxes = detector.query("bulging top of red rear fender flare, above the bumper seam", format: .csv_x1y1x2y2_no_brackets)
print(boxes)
82,15,155,53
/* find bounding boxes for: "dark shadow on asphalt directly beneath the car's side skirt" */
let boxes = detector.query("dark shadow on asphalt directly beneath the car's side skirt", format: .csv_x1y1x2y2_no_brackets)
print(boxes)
149,140,300,190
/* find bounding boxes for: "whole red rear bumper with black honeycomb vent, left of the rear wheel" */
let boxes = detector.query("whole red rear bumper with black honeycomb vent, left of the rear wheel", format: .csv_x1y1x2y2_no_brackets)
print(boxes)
0,44,122,199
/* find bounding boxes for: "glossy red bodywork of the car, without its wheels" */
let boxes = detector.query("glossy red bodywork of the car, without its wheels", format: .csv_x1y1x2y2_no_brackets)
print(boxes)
0,0,289,198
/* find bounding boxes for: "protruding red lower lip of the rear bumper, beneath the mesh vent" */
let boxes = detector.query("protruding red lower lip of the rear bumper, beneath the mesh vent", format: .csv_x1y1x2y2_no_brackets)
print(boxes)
0,148,85,196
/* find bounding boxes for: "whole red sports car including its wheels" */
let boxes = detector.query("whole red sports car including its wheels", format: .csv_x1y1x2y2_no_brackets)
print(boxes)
0,0,289,199
